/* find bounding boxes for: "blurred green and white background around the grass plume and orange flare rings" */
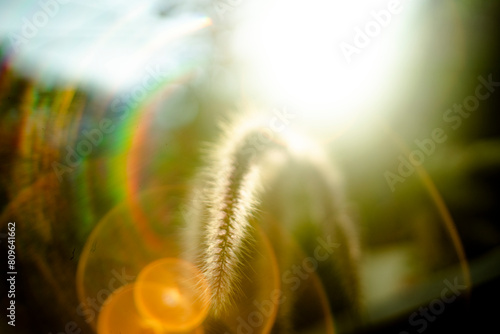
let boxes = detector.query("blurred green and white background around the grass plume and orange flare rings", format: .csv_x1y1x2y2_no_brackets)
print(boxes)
0,0,500,333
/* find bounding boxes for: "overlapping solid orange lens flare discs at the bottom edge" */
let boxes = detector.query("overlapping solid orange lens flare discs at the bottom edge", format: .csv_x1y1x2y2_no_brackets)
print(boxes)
97,258,209,334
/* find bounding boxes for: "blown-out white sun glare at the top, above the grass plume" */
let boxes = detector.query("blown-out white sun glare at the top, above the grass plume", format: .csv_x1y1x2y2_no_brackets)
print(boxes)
233,0,415,136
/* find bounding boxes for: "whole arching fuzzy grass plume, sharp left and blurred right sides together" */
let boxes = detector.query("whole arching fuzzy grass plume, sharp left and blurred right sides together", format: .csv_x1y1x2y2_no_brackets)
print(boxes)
186,117,359,324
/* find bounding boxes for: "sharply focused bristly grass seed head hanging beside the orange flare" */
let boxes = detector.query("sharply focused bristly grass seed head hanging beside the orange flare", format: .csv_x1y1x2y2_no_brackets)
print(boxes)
188,117,285,314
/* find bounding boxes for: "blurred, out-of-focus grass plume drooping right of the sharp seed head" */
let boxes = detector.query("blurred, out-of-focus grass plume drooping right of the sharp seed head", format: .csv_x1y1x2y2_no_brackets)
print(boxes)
259,140,361,333
